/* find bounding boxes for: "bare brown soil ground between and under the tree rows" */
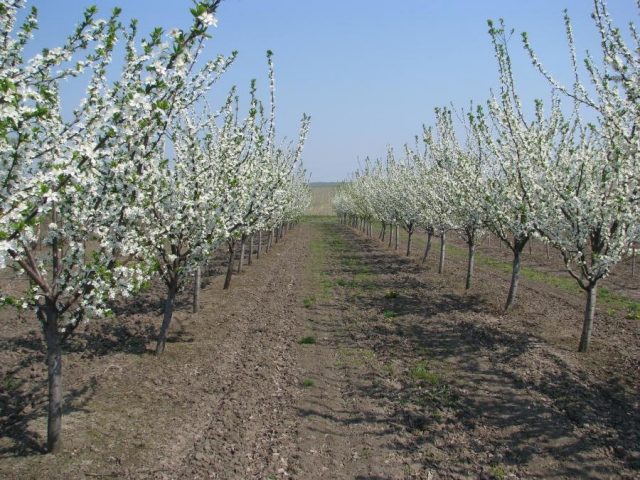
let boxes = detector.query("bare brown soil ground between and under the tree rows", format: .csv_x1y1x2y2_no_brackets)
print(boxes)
0,220,640,480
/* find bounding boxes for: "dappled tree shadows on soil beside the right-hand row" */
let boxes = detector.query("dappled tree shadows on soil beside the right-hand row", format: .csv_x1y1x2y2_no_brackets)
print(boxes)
316,223,640,478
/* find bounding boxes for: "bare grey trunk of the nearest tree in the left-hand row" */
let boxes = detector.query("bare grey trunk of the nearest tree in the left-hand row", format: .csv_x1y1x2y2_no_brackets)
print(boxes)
44,300,62,453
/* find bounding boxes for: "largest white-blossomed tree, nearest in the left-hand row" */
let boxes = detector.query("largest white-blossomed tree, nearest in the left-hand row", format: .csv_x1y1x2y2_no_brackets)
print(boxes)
0,0,225,452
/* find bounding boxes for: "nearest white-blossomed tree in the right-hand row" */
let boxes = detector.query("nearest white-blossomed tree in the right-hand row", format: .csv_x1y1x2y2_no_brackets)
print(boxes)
523,0,640,352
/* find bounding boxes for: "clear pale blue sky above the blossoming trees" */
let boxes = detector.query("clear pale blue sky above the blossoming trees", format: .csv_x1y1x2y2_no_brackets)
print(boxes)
22,0,638,181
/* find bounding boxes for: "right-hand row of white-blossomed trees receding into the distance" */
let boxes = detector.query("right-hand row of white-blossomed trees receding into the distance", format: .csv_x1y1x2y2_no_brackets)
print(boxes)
333,0,640,352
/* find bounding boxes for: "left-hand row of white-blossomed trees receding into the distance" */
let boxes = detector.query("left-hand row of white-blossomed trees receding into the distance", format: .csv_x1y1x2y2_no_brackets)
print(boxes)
0,0,309,452
